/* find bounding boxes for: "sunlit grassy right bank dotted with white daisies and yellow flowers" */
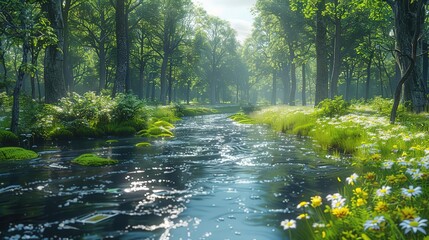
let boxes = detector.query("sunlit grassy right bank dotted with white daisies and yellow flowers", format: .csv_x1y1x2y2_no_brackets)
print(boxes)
246,99,429,239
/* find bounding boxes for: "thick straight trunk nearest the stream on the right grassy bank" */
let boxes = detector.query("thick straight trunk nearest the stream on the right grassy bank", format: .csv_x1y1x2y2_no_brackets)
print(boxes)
315,0,328,105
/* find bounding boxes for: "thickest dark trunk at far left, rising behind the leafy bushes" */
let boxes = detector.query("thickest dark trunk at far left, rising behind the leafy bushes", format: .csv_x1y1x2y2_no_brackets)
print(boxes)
42,0,67,103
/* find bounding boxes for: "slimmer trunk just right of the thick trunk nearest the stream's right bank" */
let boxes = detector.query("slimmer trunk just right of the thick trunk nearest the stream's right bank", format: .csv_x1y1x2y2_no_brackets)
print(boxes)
330,13,342,98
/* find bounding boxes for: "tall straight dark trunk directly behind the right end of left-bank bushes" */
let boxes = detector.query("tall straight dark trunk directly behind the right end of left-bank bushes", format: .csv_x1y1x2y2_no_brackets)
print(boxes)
113,0,128,96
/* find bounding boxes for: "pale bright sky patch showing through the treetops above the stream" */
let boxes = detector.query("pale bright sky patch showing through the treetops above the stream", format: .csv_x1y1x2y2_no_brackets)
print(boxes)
192,0,257,43
